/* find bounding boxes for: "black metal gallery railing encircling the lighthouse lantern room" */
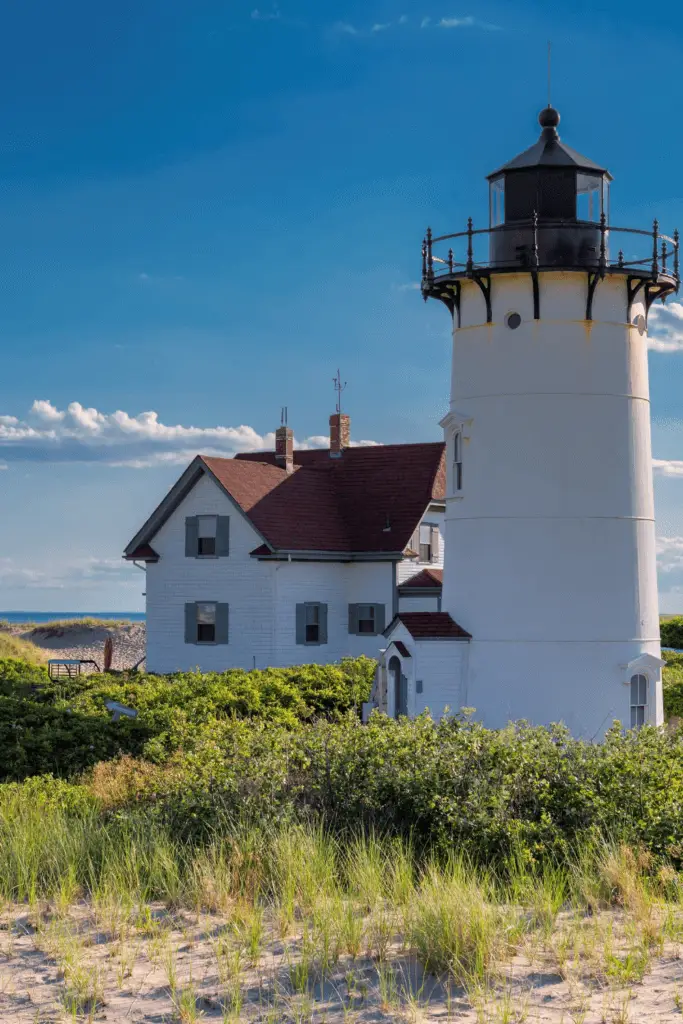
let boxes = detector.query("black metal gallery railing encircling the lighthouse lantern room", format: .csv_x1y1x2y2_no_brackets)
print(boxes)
422,214,680,292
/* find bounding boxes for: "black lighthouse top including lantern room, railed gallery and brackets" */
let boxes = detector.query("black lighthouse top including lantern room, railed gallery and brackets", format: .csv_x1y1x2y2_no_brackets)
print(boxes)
422,106,681,327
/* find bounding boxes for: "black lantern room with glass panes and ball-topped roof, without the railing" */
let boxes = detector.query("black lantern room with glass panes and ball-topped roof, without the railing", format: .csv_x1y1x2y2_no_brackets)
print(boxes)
488,106,611,268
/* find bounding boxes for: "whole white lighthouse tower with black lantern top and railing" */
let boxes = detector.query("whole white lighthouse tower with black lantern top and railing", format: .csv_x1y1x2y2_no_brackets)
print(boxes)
421,106,679,738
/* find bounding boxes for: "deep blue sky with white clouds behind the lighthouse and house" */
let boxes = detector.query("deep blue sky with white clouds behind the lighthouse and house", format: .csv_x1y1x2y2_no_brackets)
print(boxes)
0,0,683,611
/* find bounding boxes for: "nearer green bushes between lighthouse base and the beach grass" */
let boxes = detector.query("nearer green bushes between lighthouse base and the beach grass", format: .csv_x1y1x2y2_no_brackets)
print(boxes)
10,714,683,864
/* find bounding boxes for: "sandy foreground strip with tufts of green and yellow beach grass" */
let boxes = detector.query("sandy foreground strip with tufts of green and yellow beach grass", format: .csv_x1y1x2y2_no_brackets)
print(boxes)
0,786,683,1024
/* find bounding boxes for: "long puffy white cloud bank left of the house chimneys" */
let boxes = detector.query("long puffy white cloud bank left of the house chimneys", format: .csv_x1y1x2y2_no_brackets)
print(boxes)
0,399,373,469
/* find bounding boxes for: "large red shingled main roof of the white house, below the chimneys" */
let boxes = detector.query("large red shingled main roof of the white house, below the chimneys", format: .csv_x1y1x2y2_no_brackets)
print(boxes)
203,441,445,553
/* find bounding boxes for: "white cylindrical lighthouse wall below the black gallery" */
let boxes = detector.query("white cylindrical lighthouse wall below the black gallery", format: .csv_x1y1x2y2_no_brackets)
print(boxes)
442,271,661,737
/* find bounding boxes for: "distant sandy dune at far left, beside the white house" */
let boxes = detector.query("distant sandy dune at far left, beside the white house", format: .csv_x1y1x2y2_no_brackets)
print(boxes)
9,620,145,670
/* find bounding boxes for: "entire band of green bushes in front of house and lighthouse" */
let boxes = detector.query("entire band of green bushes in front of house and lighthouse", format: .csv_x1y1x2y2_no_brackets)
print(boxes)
0,655,683,863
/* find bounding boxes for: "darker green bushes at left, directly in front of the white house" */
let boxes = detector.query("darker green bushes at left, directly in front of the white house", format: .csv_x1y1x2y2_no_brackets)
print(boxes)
0,657,375,779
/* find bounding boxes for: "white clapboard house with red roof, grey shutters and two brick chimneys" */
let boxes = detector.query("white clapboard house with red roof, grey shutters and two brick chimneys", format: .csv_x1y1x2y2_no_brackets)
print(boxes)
125,413,456,712
